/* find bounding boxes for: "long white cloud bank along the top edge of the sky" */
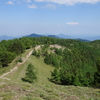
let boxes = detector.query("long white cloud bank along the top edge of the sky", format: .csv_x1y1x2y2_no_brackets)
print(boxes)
34,0,100,5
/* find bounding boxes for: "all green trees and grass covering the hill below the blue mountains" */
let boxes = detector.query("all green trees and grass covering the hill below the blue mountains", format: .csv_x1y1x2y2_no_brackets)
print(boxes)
0,37,100,100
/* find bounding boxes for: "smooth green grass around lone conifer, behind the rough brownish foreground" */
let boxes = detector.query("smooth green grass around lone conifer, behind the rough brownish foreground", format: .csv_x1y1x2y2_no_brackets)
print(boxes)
7,55,54,84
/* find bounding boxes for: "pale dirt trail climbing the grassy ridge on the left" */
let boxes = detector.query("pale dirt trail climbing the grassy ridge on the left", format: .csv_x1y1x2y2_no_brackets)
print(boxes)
0,50,33,80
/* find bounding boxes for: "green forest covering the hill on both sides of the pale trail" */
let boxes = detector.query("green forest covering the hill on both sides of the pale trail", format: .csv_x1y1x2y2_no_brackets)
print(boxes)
0,37,100,86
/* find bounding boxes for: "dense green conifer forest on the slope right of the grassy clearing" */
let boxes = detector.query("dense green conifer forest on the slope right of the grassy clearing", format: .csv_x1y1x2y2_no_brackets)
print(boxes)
33,39,100,87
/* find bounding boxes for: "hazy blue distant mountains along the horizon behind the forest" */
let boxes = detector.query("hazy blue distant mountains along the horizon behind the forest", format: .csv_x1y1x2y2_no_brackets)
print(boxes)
0,33,100,42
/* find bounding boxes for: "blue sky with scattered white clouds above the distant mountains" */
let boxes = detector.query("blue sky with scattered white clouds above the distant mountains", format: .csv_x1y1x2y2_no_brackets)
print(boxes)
0,0,100,37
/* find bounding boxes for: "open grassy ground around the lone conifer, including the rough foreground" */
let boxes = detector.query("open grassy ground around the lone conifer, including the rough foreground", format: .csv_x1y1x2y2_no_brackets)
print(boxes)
0,49,100,100
